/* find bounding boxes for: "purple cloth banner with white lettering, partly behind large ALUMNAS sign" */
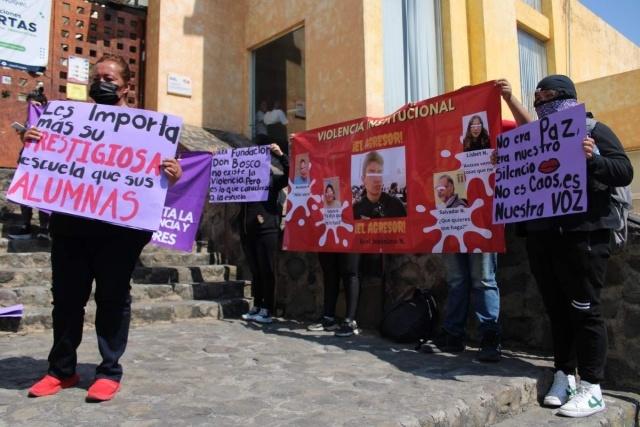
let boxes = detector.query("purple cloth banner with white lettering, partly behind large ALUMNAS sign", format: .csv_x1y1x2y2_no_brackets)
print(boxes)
151,151,211,252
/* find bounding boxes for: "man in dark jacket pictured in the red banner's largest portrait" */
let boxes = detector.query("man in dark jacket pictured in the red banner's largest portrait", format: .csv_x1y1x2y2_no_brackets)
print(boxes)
353,151,407,219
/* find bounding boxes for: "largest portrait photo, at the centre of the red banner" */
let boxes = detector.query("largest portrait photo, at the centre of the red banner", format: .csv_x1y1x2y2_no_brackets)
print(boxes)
351,146,407,220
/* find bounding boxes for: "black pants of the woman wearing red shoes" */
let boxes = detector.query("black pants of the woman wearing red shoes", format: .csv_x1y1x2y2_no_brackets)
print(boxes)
49,230,151,381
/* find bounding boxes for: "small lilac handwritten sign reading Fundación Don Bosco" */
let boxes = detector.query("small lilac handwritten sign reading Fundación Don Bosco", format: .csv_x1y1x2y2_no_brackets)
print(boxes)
209,145,271,203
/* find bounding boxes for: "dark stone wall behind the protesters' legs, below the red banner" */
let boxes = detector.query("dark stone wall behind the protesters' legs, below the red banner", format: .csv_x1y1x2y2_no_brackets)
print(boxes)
205,205,640,390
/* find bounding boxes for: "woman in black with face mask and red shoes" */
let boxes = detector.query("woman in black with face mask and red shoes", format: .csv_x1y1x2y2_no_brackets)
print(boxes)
24,54,182,401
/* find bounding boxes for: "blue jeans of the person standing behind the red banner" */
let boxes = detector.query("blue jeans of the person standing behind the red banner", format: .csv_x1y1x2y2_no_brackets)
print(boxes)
442,253,500,337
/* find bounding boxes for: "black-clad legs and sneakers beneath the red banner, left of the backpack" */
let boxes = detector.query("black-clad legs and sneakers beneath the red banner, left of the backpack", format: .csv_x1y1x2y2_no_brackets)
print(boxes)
307,252,360,337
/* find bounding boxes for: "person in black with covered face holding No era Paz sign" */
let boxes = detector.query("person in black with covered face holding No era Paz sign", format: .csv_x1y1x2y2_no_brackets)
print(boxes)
497,75,633,417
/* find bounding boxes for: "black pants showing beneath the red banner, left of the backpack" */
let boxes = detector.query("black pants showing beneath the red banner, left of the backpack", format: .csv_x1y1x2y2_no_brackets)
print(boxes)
318,252,360,320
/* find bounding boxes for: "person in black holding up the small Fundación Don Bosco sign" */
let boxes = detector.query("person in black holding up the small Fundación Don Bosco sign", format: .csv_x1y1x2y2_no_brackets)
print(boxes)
240,143,289,323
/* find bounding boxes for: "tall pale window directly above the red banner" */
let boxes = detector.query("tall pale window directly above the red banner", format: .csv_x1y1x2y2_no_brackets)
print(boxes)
382,0,444,114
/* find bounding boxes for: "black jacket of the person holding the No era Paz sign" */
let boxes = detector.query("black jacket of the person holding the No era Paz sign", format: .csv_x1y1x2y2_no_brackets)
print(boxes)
526,122,633,232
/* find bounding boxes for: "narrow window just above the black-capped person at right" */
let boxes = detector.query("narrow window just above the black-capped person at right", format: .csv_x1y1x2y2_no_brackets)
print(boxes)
518,29,548,114
